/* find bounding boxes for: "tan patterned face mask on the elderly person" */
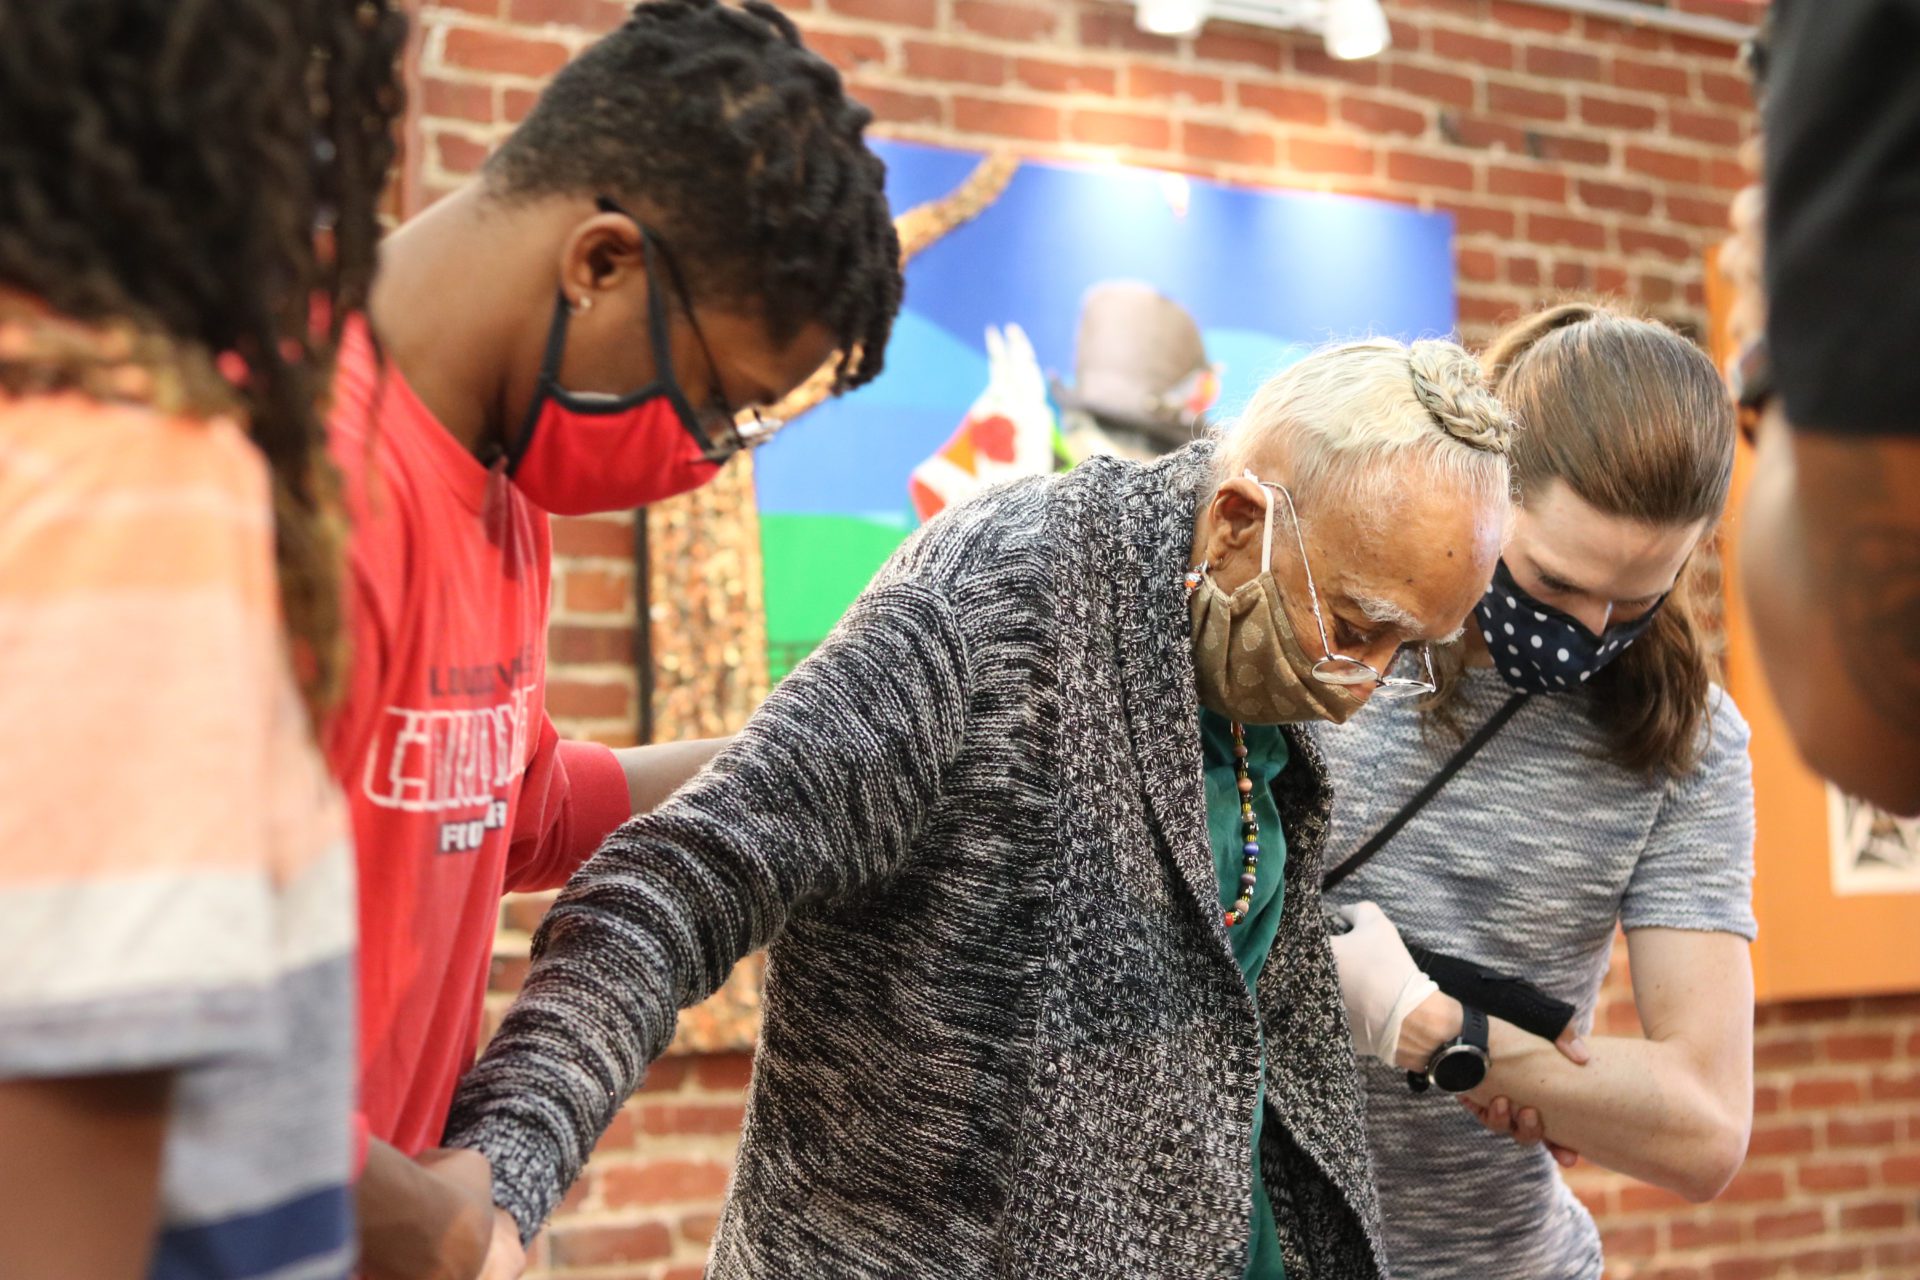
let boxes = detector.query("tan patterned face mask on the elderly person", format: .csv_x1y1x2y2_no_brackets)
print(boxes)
1187,486,1367,725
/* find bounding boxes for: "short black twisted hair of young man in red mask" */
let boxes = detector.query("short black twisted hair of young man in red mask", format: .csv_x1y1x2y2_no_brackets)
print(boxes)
488,0,900,391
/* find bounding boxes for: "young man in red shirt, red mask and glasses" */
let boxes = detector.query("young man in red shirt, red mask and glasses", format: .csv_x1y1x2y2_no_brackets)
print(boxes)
328,0,900,1280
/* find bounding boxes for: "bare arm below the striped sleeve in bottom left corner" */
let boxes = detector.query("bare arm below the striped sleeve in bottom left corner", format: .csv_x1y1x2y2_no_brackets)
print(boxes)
0,1073,169,1280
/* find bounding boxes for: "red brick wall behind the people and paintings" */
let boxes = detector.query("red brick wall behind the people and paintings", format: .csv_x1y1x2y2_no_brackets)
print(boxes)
403,0,1920,1280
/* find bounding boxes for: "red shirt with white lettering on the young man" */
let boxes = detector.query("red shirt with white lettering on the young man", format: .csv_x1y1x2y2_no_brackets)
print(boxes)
326,314,628,1155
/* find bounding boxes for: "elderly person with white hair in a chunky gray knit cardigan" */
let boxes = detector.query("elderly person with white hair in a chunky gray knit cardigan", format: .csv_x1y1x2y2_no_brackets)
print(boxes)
447,340,1509,1280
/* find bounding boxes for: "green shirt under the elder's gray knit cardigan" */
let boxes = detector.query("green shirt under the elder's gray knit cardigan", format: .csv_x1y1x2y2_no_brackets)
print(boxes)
1200,708,1286,1280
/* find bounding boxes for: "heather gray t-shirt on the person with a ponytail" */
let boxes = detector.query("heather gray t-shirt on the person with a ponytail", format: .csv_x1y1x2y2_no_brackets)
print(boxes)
1319,668,1755,1280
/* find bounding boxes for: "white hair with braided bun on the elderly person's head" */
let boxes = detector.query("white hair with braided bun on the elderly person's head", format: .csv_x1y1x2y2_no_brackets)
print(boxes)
1219,338,1513,514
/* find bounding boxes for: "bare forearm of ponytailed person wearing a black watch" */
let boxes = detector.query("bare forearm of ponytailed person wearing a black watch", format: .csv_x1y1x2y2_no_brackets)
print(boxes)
1400,996,1751,1201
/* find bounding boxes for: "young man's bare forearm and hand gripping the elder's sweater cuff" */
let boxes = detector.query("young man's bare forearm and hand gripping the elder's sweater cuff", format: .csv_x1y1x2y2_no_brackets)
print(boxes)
355,1142,493,1280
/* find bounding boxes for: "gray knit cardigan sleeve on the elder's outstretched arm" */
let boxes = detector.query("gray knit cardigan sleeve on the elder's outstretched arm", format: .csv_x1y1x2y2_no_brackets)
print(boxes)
445,581,968,1238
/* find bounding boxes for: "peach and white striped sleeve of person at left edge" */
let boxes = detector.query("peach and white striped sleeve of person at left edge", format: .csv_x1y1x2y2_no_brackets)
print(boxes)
0,395,298,1077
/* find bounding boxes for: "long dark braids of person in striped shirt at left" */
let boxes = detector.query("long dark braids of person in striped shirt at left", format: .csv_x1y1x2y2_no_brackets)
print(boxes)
0,0,405,721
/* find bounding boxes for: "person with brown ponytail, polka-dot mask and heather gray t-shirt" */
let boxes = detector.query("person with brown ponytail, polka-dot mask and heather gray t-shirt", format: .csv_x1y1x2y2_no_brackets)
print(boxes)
1323,303,1755,1280
